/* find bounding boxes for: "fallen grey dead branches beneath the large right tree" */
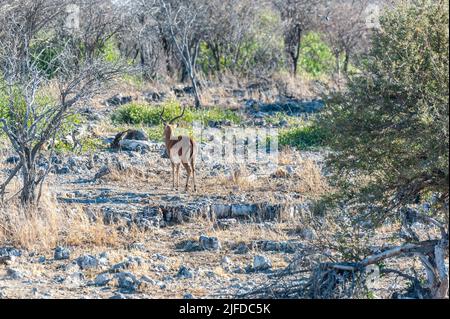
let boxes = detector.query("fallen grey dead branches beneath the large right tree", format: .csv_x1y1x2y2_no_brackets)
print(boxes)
244,239,448,299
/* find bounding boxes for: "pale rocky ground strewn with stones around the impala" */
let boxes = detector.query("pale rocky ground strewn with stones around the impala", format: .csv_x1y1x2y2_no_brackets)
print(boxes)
0,86,325,298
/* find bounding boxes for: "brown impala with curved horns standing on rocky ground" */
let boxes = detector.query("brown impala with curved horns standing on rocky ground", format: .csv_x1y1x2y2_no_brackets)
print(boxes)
159,107,198,191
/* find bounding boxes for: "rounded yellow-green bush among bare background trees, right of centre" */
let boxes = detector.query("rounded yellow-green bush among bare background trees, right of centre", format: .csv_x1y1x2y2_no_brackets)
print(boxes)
299,32,335,76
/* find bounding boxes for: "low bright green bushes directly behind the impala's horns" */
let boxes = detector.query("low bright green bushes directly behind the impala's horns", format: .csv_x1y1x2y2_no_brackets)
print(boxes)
112,101,241,126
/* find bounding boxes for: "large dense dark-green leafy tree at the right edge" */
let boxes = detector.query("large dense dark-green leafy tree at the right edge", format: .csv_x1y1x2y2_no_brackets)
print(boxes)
320,0,449,298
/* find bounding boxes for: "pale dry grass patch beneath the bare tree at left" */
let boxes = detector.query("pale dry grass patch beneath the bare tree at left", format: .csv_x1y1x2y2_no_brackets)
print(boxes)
0,184,125,250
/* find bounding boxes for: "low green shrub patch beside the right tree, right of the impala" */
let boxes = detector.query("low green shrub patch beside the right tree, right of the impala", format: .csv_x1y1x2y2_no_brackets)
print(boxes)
279,124,325,150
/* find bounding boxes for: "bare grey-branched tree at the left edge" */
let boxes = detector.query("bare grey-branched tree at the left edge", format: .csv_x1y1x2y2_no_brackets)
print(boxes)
0,0,121,205
